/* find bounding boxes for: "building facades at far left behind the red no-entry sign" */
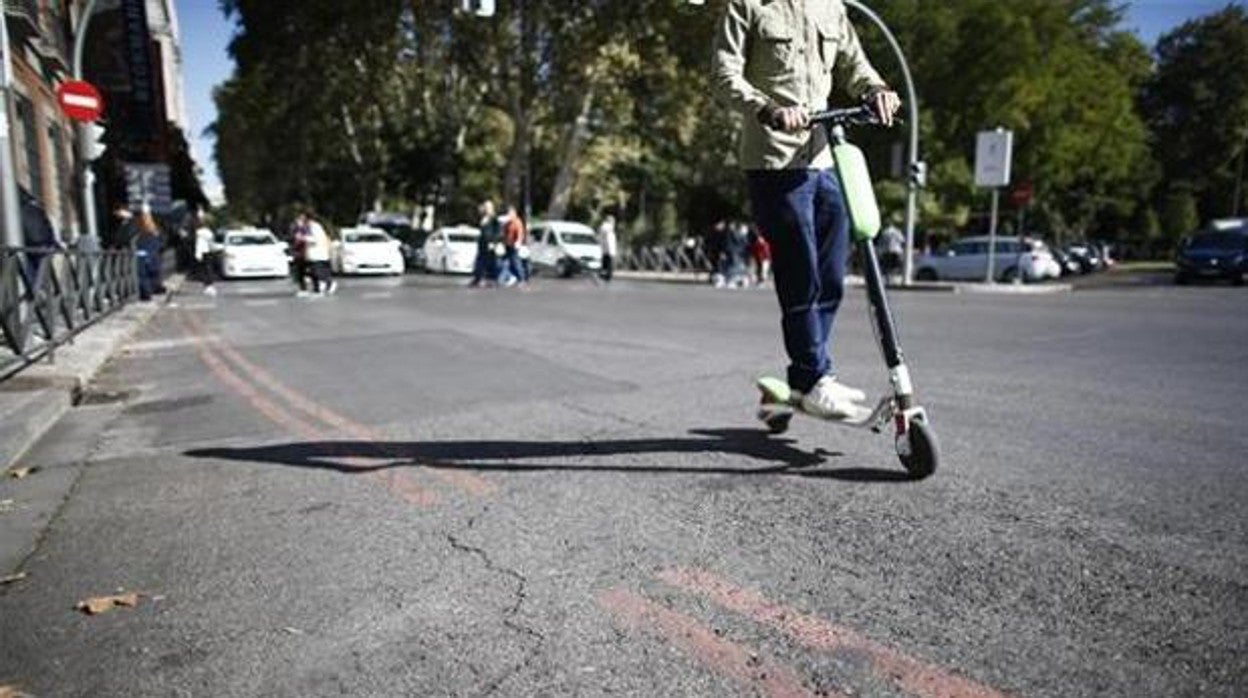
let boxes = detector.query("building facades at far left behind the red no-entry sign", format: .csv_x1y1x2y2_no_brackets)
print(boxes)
0,0,202,242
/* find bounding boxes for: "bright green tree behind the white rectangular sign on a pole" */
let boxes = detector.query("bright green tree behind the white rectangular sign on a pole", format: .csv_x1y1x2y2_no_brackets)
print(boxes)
859,0,1153,245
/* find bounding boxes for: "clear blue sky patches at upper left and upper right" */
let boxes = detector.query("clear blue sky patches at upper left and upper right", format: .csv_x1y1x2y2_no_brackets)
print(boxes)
177,0,1248,200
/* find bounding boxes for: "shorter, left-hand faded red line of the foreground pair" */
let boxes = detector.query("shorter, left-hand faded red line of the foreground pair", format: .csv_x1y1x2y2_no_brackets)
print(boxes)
598,588,815,698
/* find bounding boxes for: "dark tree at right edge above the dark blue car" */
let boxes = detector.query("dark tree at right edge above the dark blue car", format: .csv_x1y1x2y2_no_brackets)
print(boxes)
1142,5,1248,220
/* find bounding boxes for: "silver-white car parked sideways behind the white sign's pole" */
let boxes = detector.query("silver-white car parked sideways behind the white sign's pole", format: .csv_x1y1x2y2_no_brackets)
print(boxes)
915,236,1062,281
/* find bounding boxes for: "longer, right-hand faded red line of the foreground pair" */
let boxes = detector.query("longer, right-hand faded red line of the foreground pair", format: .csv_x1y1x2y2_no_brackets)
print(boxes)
658,569,1005,698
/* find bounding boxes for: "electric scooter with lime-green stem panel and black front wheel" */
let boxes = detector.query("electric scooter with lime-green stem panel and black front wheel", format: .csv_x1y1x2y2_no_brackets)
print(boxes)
758,106,940,479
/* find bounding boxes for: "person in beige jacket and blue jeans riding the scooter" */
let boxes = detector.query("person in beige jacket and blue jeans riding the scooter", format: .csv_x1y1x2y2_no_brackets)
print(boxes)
711,0,901,418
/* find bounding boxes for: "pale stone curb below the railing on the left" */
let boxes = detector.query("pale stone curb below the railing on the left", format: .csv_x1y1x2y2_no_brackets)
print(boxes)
0,275,185,472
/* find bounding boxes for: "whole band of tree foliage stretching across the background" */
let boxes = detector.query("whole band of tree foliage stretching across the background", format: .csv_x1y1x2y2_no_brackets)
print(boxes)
204,0,1228,250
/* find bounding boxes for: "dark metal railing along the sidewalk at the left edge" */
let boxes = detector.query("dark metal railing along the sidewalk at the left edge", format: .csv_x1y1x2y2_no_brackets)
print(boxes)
0,247,139,378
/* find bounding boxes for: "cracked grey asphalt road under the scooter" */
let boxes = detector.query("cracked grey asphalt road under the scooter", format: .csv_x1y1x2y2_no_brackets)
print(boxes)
0,270,1248,697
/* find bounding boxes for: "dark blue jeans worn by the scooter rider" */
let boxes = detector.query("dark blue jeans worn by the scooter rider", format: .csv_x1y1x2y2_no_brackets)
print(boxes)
746,170,850,392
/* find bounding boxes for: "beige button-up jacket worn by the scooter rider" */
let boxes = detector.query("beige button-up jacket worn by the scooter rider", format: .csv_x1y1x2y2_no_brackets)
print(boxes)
711,0,886,170
